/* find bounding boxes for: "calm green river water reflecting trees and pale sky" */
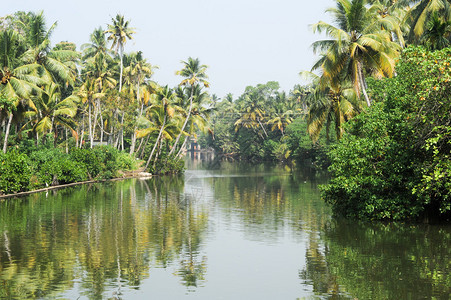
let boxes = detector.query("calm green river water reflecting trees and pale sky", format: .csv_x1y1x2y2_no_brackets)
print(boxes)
0,161,451,299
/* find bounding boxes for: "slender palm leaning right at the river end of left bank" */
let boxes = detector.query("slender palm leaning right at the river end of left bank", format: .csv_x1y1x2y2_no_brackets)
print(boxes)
169,57,209,155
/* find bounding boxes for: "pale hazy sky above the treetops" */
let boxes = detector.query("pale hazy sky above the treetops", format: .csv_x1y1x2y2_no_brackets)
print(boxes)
0,0,334,97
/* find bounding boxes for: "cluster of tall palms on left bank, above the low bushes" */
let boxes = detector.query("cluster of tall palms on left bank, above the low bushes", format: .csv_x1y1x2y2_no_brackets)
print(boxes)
0,11,210,188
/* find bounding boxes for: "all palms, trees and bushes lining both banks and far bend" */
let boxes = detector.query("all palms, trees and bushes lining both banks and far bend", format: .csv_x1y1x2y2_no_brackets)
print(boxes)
0,0,451,219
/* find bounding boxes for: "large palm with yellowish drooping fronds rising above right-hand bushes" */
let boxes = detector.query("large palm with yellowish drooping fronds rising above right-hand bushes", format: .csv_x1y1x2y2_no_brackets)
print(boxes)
312,0,400,106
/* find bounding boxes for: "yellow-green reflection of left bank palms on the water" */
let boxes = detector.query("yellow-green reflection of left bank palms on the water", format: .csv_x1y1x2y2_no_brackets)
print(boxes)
0,178,208,299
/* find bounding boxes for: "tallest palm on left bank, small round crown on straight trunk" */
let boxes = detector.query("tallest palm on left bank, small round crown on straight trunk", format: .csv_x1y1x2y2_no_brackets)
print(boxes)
105,14,135,92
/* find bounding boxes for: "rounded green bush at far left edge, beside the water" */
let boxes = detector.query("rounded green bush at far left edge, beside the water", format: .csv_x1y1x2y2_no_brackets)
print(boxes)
0,150,31,194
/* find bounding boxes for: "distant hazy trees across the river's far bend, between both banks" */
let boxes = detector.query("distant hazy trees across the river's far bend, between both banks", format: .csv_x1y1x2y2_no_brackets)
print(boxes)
200,81,336,167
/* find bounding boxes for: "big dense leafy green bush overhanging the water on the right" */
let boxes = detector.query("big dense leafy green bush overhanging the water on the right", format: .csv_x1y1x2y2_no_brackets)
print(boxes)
323,47,451,219
